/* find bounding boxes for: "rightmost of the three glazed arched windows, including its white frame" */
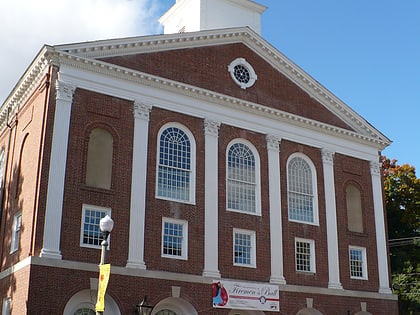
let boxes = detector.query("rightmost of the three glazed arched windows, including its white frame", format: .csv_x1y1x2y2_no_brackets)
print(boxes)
287,154,318,224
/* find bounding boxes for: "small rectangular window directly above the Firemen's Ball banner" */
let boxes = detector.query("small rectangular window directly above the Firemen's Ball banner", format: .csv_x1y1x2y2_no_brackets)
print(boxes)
233,229,255,267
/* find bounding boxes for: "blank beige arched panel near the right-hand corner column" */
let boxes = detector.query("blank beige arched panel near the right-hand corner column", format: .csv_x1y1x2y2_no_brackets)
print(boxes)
346,184,363,233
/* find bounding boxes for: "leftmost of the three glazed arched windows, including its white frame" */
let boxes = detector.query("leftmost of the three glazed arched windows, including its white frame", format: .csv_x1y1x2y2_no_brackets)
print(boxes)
156,124,195,203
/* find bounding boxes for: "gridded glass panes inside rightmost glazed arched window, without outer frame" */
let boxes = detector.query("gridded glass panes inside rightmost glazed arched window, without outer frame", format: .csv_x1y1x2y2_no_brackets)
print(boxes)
287,157,314,222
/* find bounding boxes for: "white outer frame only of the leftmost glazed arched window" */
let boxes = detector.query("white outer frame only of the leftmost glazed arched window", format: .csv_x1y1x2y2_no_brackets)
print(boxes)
155,122,196,204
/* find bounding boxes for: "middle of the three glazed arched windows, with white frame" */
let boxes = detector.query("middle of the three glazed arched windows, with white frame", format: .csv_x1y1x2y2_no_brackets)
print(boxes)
226,140,261,214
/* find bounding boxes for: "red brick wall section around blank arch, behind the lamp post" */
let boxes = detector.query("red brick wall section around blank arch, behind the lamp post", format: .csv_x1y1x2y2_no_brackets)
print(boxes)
61,89,134,266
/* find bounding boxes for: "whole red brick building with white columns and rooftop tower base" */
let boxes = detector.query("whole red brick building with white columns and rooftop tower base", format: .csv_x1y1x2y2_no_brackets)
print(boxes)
0,0,398,315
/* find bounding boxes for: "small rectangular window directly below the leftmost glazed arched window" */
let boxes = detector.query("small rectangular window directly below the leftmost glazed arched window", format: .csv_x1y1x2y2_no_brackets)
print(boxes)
162,218,188,259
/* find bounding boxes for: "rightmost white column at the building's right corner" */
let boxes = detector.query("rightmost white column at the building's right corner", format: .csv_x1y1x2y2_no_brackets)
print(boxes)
370,161,392,294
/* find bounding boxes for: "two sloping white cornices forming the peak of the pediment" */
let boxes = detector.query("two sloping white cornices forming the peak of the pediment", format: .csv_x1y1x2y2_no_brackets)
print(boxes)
52,27,391,145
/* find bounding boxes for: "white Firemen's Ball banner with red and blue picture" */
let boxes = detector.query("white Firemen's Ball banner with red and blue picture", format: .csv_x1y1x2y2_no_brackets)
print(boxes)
212,280,280,312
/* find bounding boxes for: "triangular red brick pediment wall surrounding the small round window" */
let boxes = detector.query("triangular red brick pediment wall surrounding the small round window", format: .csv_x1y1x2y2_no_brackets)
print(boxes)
101,44,351,130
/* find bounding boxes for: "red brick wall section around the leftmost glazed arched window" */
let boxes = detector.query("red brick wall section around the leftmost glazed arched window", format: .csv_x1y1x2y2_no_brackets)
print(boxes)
144,107,204,274
